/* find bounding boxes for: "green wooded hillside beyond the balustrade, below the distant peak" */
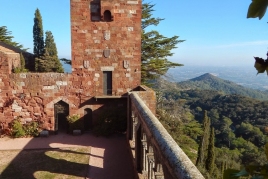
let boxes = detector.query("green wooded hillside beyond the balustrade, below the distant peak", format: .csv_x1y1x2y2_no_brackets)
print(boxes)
155,80,268,179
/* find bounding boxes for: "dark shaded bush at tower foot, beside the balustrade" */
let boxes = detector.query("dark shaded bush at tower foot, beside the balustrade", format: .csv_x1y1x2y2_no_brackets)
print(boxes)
93,107,127,137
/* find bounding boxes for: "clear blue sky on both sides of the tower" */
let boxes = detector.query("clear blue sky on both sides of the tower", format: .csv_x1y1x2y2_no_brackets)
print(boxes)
0,0,268,66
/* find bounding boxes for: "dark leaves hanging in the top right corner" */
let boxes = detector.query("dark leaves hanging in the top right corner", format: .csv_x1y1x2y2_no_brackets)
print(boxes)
247,0,268,19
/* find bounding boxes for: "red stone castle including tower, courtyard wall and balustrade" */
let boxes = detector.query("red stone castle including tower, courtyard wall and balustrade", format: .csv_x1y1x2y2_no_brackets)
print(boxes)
0,0,204,179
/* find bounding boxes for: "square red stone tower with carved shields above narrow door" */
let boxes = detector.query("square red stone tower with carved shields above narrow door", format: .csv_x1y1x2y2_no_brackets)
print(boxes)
71,0,141,98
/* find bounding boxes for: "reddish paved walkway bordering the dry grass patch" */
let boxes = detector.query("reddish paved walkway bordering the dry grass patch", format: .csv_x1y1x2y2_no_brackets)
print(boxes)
0,134,136,179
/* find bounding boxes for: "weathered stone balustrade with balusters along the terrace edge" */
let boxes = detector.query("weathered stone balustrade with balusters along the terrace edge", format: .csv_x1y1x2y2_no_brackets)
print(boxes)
128,92,204,179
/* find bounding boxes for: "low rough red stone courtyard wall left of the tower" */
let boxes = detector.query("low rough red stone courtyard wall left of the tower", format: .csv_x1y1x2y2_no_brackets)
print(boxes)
0,73,73,130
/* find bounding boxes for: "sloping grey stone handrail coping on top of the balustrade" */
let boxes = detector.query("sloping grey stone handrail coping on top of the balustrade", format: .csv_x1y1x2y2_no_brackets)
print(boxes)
130,92,204,179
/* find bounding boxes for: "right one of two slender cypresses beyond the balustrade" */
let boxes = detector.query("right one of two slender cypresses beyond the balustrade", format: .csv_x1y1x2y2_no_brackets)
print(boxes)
206,128,215,175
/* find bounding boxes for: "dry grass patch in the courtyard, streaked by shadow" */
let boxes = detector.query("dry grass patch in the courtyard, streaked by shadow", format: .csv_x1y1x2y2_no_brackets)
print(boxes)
0,147,90,179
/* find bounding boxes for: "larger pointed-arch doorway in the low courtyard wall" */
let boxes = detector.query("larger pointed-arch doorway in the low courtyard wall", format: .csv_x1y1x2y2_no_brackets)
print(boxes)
54,100,69,134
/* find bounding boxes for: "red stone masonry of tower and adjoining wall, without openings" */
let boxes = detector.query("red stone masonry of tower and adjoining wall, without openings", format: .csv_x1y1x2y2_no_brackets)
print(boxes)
0,0,141,130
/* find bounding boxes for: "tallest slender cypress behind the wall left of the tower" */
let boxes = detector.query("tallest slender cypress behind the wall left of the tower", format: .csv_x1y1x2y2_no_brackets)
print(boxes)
33,8,44,57
